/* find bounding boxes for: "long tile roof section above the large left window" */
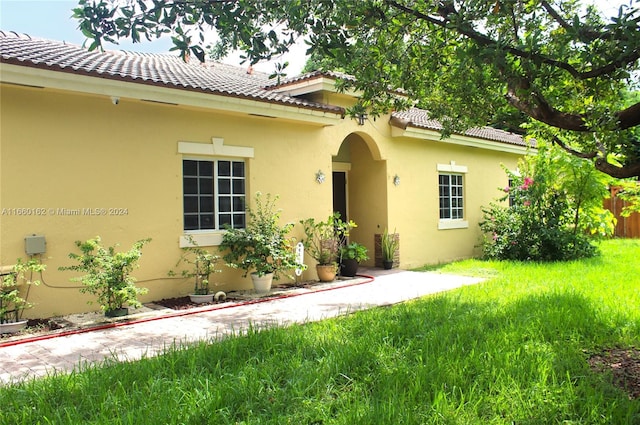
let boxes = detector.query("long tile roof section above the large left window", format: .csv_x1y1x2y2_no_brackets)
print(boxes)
0,31,344,115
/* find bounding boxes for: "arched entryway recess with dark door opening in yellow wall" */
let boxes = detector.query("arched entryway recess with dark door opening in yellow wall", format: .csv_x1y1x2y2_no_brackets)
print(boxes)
333,133,388,265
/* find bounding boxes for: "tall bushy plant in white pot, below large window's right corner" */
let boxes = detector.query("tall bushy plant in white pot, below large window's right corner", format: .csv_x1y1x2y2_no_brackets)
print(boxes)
219,192,304,293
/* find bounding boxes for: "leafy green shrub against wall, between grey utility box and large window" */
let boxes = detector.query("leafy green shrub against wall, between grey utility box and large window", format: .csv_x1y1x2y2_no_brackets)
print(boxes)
60,236,151,317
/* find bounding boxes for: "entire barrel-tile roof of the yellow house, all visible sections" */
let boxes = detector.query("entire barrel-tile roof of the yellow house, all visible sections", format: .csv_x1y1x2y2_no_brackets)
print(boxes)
0,30,526,146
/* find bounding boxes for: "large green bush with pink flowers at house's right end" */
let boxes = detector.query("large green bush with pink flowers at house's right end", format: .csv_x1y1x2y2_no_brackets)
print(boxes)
480,144,614,261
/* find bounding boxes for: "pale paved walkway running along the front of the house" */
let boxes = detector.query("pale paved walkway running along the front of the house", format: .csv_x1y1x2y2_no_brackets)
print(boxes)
0,269,482,384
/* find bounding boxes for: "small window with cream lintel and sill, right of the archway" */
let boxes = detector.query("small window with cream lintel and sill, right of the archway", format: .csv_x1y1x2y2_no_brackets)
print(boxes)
438,161,469,229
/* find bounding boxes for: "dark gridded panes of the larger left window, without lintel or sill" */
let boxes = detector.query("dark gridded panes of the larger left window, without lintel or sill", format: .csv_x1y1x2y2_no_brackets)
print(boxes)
182,158,246,231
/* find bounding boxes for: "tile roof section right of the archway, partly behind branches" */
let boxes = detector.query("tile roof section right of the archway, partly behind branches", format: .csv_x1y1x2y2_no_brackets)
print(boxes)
391,108,535,147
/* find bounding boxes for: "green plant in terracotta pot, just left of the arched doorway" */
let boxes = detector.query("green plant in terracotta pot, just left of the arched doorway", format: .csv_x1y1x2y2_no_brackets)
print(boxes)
300,212,357,282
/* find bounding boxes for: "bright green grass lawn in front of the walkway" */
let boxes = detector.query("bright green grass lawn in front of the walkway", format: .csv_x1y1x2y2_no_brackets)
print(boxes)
0,240,640,425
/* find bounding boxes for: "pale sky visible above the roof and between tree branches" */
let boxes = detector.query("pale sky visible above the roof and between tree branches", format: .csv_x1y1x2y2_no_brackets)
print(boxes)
0,0,632,75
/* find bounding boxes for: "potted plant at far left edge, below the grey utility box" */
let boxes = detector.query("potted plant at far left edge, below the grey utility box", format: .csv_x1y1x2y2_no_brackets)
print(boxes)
0,258,47,334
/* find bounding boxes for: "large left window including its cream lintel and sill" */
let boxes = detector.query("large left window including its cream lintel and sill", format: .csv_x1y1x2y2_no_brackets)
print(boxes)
178,137,254,247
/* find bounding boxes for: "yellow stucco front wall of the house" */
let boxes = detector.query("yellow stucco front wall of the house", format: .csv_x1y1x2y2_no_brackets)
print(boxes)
0,81,517,317
